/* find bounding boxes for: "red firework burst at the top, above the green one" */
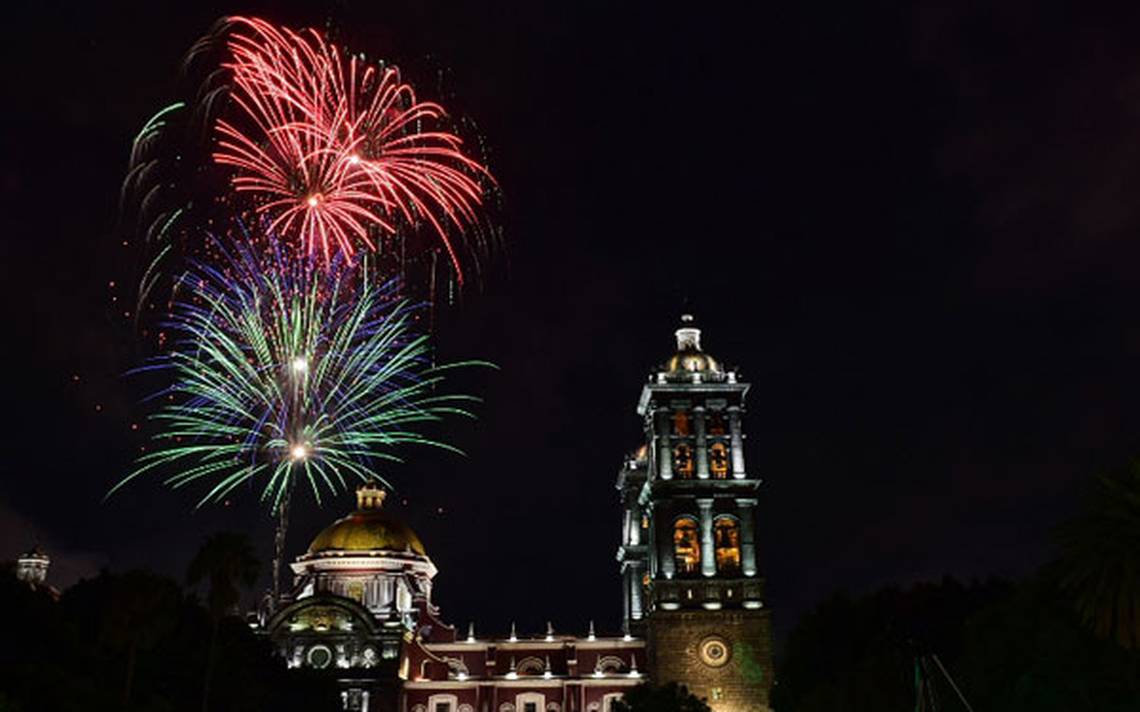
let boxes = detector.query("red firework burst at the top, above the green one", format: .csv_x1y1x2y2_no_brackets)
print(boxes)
214,18,492,277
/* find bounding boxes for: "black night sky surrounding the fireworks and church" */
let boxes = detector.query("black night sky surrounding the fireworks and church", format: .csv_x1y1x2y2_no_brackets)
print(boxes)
0,0,1140,632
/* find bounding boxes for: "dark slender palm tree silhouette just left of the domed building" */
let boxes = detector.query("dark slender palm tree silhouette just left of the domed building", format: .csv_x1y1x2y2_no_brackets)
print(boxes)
186,532,261,712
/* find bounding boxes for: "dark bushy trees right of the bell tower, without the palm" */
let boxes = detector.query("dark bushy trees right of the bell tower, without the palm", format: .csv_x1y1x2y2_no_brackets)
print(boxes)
773,576,1140,712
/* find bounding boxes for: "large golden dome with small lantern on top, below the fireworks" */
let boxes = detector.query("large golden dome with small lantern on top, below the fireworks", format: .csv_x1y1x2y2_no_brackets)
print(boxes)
309,483,428,556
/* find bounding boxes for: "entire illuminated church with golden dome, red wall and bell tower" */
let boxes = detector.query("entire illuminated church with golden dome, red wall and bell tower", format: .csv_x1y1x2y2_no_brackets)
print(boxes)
258,317,772,712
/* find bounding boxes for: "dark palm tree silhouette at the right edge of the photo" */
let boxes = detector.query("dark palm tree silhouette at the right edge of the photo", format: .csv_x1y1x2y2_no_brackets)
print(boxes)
1056,461,1140,648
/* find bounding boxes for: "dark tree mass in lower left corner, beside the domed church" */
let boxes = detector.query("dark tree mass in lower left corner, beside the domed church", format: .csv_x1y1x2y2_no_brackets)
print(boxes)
0,562,335,712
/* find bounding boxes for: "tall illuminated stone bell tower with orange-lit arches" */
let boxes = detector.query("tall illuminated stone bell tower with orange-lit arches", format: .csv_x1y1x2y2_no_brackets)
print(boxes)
618,314,772,712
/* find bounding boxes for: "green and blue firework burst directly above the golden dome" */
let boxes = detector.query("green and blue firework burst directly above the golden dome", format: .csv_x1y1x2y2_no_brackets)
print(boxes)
108,230,490,509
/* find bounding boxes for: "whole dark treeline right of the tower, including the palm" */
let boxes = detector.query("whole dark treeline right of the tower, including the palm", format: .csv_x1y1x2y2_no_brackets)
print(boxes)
773,464,1140,712
